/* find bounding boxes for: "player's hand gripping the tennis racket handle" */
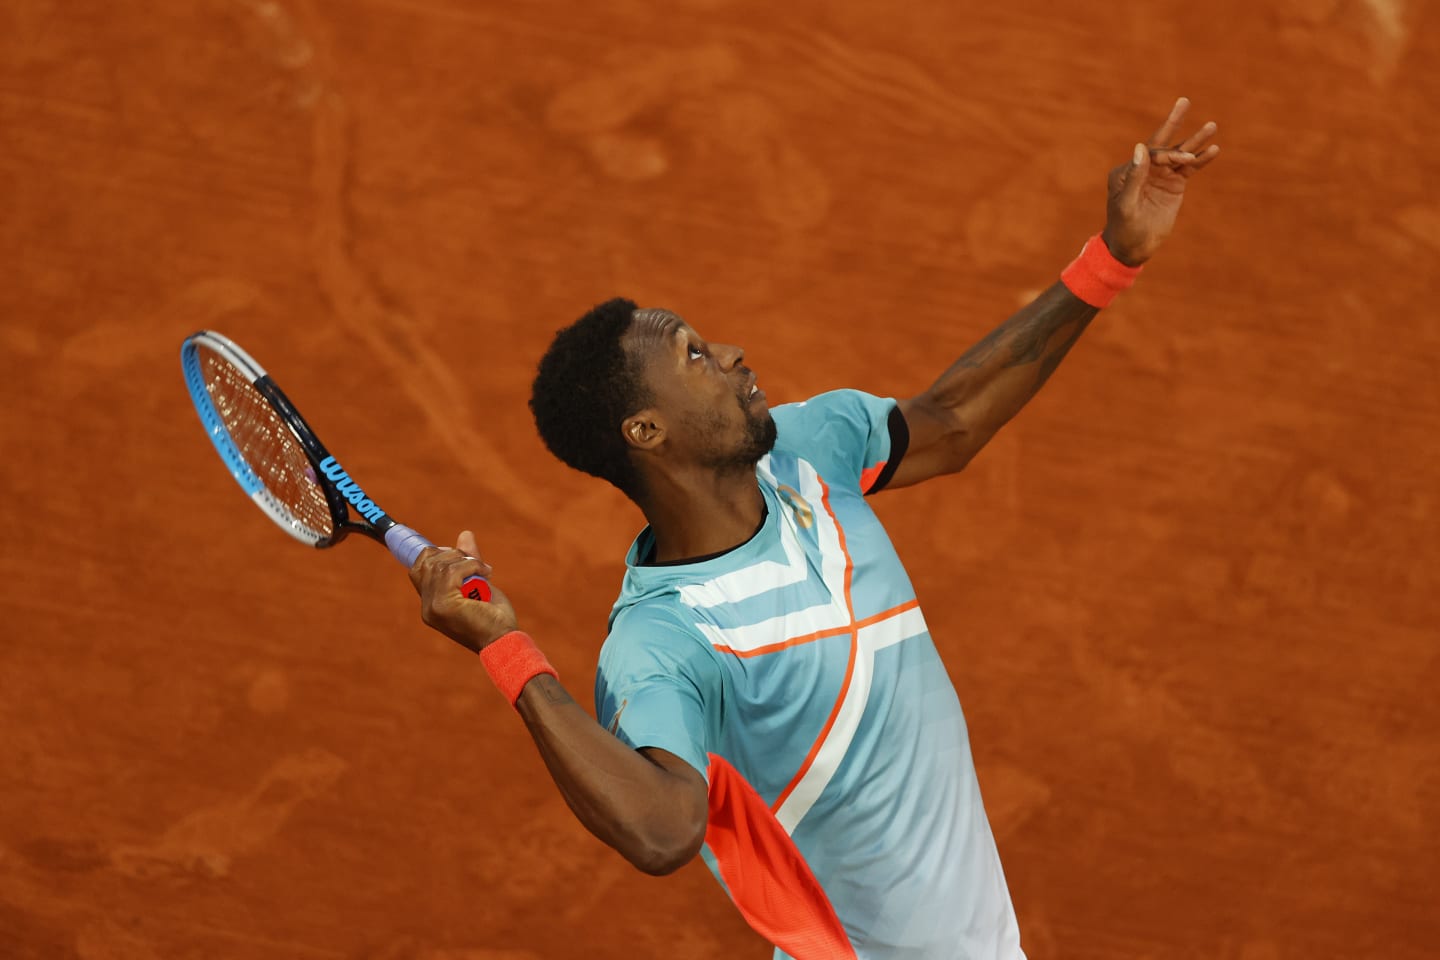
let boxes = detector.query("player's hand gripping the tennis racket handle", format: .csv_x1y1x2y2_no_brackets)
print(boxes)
410,530,517,653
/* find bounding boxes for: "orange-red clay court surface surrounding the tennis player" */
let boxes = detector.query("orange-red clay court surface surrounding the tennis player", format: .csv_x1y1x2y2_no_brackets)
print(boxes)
0,0,1440,960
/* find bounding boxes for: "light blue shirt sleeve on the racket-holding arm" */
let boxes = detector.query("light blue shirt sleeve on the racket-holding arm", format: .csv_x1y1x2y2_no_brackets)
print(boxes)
595,609,721,780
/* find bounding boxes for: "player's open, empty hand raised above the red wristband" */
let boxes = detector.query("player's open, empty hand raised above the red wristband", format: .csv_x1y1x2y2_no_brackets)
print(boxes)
1103,96,1220,266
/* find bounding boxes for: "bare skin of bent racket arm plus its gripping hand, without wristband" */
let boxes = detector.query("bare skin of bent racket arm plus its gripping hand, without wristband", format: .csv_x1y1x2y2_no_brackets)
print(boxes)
410,533,708,875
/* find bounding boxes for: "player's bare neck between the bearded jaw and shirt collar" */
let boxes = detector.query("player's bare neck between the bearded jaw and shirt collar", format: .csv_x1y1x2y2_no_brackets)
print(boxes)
641,466,765,563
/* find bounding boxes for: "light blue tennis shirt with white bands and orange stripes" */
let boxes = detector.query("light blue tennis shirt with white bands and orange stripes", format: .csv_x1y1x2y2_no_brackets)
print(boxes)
595,390,1024,960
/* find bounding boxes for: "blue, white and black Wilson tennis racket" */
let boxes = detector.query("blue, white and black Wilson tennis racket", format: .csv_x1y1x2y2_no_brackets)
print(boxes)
180,330,490,600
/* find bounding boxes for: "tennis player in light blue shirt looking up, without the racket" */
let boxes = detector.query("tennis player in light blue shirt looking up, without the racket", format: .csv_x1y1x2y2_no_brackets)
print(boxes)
410,99,1220,960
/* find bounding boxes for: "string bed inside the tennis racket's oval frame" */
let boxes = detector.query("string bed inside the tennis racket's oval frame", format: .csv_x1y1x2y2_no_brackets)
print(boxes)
202,350,334,537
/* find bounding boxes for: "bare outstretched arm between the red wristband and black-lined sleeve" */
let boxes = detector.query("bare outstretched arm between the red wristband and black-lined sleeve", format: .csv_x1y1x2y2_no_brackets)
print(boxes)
907,282,1099,471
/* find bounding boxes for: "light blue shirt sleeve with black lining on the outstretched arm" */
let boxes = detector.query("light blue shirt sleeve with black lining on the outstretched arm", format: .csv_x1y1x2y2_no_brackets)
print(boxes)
772,390,910,494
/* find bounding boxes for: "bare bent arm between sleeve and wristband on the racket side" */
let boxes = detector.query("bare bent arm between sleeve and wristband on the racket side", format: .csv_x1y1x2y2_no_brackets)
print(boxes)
516,675,706,874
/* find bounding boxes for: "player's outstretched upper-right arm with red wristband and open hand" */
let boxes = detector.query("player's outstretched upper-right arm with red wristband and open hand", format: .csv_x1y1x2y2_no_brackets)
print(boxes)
888,98,1220,489
